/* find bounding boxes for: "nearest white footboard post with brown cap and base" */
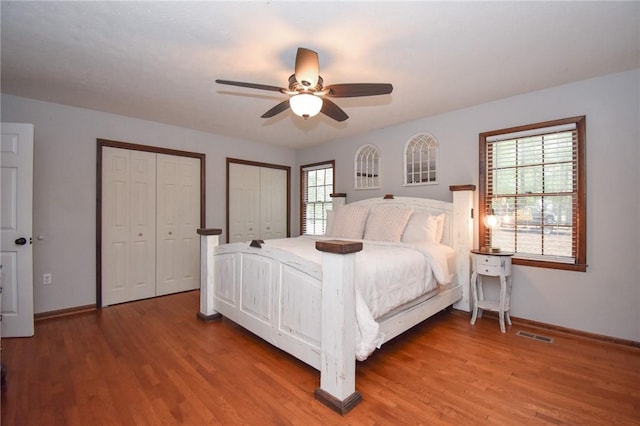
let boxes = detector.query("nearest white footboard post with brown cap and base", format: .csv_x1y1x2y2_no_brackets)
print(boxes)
315,240,362,415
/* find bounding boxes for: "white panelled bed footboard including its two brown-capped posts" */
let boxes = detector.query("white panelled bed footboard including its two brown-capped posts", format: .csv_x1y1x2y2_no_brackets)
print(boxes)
198,229,362,414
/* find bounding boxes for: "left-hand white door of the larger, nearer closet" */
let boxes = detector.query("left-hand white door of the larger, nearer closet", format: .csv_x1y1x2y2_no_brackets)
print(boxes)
102,147,156,306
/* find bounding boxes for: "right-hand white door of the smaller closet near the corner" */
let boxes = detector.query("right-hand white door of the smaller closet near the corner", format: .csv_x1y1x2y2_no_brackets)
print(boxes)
260,167,287,240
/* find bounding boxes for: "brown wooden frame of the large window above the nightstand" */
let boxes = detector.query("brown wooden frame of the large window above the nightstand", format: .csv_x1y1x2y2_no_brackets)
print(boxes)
478,116,587,272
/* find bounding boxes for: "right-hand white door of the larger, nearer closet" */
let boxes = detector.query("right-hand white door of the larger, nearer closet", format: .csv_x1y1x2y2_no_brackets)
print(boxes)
156,154,200,295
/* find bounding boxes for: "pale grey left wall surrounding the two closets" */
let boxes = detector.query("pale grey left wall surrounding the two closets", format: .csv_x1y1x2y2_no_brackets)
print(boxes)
2,94,295,313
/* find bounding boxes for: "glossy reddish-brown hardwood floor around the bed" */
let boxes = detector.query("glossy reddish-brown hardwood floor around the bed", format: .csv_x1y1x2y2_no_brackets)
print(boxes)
1,292,640,425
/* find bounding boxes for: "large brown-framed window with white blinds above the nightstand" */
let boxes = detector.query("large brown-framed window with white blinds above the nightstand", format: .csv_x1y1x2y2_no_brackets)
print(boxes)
479,116,587,271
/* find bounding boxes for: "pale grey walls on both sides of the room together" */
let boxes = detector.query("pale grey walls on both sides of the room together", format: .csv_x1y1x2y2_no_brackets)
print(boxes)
2,70,640,341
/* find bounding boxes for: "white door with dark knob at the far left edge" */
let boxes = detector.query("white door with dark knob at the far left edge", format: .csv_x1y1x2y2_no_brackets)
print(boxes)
0,123,34,337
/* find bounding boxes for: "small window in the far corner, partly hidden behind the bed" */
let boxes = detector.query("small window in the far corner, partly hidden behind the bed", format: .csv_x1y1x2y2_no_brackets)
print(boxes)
300,161,335,235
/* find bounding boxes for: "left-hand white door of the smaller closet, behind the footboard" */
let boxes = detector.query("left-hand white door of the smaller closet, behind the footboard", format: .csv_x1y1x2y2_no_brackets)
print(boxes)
228,163,261,243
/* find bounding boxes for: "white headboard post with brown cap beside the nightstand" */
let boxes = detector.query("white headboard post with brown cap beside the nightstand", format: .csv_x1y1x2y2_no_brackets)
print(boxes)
449,185,476,312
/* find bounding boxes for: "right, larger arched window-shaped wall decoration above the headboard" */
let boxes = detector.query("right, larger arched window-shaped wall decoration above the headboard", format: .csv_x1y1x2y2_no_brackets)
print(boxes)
404,133,438,185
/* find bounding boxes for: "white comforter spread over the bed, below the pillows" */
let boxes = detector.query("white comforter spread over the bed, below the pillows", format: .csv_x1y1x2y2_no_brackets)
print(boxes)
265,236,453,361
